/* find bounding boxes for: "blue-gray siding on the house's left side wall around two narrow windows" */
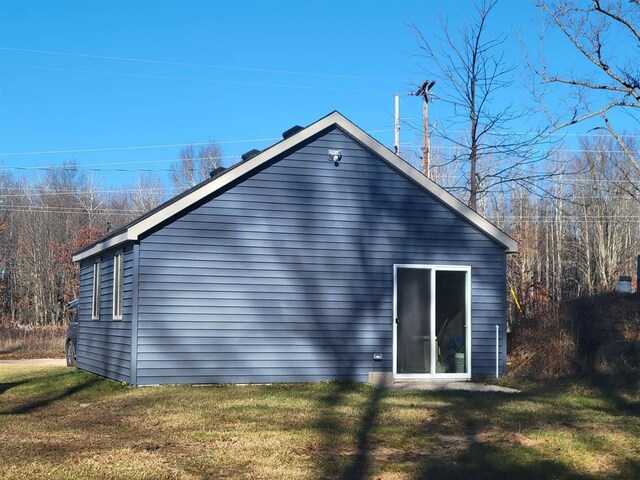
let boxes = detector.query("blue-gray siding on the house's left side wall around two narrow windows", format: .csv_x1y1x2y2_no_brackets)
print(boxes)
78,246,133,382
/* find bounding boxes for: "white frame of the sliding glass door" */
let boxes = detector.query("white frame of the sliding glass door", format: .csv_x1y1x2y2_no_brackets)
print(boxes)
391,263,472,381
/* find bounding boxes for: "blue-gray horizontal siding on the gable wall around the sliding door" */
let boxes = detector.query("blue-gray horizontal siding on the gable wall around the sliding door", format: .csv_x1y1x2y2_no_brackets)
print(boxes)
137,125,505,385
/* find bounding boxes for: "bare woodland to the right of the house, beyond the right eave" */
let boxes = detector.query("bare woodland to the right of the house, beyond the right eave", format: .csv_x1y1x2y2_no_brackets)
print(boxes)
500,139,640,315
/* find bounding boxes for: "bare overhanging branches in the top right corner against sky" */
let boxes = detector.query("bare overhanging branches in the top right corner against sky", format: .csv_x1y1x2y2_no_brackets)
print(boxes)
534,0,640,170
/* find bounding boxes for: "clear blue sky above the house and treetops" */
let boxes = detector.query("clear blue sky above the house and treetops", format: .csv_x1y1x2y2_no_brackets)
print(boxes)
0,0,632,190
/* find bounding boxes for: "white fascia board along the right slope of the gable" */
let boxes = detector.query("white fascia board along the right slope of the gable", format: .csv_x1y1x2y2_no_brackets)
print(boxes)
337,114,518,253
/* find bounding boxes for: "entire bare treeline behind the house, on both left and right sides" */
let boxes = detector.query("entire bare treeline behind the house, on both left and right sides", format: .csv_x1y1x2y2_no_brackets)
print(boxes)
0,139,640,325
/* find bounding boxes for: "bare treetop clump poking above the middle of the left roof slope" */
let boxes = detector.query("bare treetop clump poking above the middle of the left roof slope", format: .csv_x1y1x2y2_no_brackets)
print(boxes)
171,142,222,192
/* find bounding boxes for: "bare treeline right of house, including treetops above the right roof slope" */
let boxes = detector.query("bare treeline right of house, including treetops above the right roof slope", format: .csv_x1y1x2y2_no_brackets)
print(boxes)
422,135,640,320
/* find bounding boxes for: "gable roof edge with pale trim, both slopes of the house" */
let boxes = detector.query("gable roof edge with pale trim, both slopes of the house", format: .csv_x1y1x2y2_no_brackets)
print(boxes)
73,111,518,262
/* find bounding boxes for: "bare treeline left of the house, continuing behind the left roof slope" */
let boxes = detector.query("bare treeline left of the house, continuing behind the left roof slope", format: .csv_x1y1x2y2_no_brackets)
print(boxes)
0,144,221,326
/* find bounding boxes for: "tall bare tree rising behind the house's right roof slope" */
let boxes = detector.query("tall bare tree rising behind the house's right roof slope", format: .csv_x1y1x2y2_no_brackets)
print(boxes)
413,0,549,211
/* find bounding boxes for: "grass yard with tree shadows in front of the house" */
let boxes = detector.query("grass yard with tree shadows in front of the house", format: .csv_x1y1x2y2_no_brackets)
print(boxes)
0,366,640,480
